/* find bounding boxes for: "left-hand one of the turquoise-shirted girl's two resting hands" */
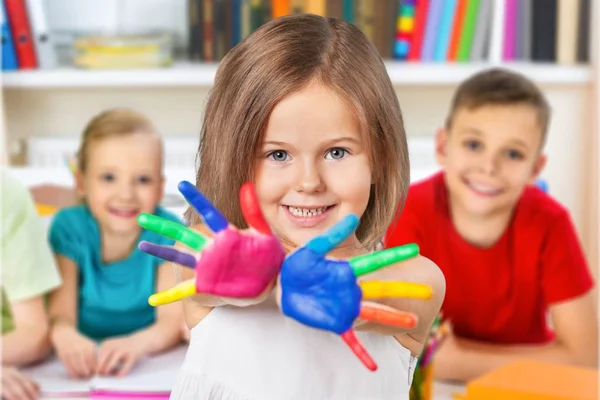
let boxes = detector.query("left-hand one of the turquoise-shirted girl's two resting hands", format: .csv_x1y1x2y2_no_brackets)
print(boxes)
51,324,97,379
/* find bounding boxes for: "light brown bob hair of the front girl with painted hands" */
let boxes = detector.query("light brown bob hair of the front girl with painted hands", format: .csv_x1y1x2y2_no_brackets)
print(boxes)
186,14,410,248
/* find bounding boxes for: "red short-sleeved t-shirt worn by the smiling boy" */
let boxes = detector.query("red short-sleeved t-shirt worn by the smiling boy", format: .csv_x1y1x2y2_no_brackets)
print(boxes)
385,172,593,344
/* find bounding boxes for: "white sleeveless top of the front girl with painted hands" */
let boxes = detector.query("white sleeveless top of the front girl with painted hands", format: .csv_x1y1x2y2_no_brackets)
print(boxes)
171,297,417,400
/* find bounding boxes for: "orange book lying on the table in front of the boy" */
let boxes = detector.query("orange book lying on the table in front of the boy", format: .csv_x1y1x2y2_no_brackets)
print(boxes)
462,361,599,400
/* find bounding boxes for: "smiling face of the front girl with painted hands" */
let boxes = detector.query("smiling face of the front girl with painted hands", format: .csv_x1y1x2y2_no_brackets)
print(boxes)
255,83,372,256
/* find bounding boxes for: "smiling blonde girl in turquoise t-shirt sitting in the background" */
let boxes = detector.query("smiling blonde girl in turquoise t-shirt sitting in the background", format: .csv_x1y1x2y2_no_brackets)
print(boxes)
49,109,183,378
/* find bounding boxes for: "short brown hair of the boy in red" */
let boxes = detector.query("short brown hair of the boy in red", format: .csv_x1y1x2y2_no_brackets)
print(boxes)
446,68,551,146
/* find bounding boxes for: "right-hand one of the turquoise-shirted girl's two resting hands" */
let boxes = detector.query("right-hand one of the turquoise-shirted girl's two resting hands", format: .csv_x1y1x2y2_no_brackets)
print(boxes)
96,336,144,376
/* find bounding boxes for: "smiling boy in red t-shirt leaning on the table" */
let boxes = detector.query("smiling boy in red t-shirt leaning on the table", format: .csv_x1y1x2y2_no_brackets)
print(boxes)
386,69,598,381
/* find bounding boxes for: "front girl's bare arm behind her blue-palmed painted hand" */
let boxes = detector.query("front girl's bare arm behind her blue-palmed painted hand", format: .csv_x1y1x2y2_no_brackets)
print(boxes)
356,256,446,355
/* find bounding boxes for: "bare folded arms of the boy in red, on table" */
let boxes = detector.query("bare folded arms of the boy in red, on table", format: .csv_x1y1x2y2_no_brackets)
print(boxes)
434,293,598,382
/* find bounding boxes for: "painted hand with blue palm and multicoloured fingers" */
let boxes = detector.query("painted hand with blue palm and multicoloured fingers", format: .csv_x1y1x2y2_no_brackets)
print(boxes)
279,214,432,371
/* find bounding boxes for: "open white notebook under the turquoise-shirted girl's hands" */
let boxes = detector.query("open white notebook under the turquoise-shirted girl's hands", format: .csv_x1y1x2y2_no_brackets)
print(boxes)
23,345,187,399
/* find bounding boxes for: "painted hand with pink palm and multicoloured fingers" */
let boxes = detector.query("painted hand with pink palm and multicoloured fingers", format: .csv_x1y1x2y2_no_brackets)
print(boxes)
138,182,285,306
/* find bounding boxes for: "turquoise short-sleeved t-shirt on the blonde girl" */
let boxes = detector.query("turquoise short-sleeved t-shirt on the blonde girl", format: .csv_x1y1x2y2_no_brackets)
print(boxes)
49,205,181,340
